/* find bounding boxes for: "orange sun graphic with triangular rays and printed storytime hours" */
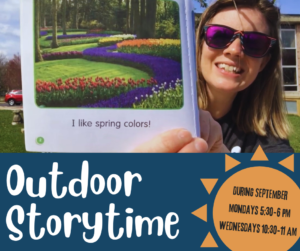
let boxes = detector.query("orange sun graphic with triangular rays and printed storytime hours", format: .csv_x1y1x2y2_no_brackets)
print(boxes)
192,146,300,251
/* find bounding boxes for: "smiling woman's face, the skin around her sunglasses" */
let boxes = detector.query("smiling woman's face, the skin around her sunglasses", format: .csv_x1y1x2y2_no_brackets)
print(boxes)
201,8,269,94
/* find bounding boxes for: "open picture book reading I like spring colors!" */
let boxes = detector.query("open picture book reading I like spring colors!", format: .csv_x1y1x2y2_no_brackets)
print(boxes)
21,0,199,152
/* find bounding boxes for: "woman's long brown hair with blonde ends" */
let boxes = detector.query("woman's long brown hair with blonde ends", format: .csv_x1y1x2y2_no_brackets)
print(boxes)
196,0,290,139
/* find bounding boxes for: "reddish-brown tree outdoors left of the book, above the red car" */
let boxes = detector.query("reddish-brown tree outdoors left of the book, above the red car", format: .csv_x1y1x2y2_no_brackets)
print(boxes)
4,54,22,90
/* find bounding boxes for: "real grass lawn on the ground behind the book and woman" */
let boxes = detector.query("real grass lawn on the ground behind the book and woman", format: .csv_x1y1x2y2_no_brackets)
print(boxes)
0,110,300,153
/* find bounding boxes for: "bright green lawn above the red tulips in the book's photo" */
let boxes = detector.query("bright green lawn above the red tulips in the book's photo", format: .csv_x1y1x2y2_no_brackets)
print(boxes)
35,59,151,82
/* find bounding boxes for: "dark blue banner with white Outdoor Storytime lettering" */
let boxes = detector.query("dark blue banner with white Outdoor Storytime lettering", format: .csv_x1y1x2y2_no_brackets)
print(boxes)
0,154,300,250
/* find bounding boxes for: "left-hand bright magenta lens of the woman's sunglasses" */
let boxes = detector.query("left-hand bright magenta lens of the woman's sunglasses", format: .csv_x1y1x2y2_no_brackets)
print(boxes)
206,26,234,48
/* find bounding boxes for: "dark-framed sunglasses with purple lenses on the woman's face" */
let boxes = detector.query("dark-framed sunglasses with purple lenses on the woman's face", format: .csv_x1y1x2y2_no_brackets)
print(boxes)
204,24,277,58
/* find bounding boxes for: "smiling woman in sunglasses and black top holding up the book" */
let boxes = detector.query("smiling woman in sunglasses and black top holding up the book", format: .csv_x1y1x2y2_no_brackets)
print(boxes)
135,0,293,152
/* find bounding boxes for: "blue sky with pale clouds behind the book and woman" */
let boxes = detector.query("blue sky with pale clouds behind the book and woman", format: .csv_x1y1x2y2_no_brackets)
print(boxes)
0,0,300,59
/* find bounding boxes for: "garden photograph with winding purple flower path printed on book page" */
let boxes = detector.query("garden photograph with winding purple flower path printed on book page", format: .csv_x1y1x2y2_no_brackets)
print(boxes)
34,0,183,109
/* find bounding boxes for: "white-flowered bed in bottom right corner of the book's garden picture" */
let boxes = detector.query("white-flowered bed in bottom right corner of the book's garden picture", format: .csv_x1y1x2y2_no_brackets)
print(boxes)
133,79,183,109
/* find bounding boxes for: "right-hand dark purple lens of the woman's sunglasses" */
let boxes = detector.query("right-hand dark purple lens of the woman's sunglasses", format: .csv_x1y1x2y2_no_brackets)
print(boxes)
243,33,271,57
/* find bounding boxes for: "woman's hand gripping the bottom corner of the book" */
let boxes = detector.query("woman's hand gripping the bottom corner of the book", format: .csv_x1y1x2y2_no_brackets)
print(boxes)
133,110,229,153
